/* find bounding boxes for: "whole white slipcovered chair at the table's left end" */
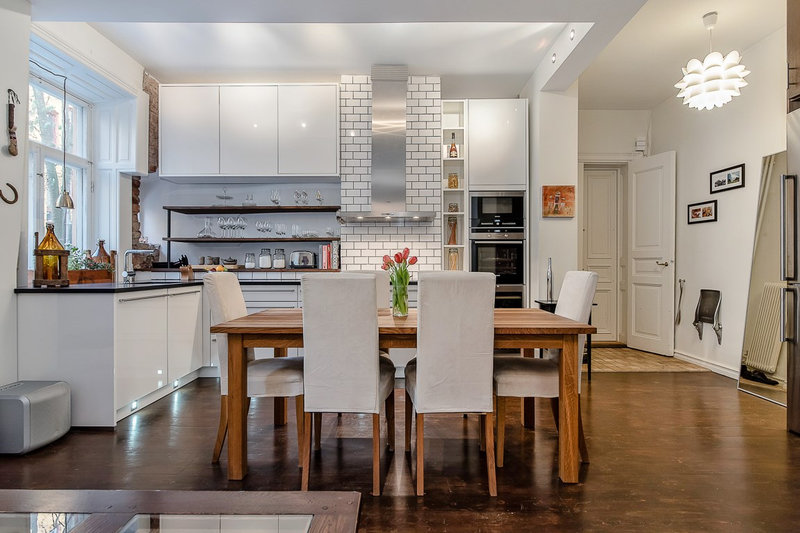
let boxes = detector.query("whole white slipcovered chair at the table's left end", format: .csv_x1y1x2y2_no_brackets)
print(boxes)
203,272,303,464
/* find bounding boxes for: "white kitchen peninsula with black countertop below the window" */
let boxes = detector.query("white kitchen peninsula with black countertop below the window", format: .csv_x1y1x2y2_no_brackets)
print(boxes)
15,281,205,427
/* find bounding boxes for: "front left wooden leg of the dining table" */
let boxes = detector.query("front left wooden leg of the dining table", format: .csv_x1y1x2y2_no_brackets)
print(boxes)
228,333,247,479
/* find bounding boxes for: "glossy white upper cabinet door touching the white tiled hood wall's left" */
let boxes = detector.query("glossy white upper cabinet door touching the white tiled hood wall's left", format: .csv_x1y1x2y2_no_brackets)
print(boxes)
278,85,339,175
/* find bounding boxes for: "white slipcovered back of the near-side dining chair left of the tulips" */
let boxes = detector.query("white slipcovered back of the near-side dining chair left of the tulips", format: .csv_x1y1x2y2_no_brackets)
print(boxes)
301,273,383,413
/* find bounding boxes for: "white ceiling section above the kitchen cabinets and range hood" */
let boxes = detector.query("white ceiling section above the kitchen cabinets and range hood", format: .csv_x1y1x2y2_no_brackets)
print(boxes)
86,22,564,98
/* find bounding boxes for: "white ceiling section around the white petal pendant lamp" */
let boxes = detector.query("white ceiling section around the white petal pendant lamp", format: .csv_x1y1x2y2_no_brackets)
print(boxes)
579,0,786,109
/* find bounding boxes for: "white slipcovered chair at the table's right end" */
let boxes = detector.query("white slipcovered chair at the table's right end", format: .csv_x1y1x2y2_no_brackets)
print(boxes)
494,270,597,467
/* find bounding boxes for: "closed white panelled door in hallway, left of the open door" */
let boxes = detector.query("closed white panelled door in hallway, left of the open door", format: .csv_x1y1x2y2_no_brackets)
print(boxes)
583,168,619,342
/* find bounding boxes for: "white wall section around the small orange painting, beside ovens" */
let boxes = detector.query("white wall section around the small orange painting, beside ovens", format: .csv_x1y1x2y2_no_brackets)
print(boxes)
520,81,580,302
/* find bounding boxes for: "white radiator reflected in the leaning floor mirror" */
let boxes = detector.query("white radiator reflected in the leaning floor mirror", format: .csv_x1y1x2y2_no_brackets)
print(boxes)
745,282,786,374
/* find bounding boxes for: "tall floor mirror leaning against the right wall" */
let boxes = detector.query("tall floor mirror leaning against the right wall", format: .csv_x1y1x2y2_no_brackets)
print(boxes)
739,152,787,405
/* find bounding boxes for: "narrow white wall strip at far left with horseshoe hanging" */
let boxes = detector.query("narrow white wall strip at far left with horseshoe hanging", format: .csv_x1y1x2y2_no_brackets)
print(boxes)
0,0,30,385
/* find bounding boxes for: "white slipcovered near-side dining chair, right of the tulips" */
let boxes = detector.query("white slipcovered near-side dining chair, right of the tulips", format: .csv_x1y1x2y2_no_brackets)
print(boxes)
405,272,497,496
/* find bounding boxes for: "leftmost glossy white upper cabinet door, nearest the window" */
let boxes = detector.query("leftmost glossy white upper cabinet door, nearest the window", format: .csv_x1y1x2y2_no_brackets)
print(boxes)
159,85,219,176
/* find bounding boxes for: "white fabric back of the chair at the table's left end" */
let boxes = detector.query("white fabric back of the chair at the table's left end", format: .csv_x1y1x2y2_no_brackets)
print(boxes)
203,272,250,395
